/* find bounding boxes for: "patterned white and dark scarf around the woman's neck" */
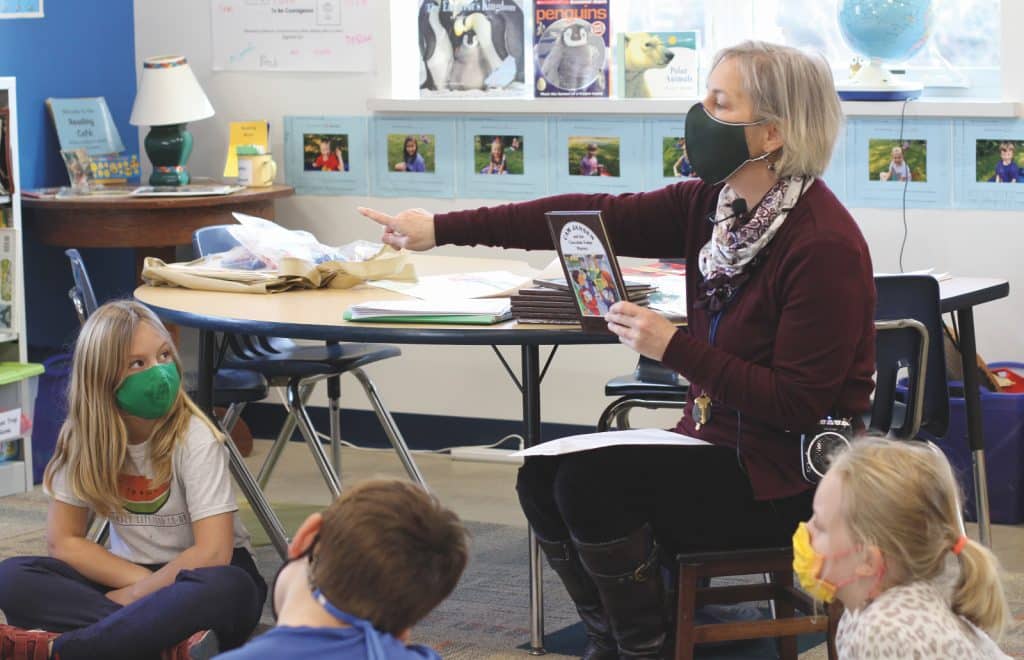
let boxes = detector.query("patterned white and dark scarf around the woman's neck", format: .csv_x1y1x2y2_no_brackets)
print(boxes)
694,176,806,312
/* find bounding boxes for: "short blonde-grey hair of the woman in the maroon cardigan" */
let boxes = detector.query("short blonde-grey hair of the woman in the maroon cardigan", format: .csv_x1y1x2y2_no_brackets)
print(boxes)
712,41,843,177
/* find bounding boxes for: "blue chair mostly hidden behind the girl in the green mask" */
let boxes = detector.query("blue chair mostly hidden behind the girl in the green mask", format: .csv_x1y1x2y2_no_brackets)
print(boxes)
65,248,269,542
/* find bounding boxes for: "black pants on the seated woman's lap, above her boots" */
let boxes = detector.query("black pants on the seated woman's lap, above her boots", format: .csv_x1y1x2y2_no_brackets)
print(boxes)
516,446,813,554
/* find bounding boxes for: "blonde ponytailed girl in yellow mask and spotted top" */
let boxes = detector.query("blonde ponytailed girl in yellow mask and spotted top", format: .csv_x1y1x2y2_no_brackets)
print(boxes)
793,438,1009,660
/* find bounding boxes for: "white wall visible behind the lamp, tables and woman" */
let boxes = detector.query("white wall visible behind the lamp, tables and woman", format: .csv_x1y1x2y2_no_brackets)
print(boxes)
135,0,1024,431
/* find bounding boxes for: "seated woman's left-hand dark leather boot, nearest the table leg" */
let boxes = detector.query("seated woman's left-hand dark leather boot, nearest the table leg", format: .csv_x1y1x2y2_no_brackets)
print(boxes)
537,536,618,660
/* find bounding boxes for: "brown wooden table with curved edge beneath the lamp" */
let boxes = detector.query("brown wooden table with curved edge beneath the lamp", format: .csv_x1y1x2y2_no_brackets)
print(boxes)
22,185,295,281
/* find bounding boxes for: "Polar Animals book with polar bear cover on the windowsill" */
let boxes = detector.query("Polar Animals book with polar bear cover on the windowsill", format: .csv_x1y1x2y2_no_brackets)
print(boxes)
615,31,699,98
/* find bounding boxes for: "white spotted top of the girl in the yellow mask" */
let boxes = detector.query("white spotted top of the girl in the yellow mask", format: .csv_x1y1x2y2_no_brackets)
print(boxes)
836,582,1010,660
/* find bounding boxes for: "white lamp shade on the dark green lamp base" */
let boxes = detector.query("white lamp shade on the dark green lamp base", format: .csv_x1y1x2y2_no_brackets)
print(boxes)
128,55,213,126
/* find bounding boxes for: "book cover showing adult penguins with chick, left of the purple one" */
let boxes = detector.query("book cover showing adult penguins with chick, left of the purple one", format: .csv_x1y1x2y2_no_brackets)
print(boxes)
418,0,529,97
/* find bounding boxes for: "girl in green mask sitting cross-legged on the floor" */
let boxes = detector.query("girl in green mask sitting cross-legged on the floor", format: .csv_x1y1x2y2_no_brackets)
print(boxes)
0,301,266,660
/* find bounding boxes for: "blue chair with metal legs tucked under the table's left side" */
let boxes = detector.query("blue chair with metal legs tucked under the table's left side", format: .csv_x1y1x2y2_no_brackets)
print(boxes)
193,225,426,495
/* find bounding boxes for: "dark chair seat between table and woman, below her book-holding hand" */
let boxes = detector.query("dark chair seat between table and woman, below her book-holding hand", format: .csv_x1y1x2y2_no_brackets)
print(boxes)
597,355,690,432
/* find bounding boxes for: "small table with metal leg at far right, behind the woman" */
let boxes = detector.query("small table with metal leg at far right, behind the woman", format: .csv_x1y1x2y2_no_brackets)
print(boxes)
939,277,1010,547
